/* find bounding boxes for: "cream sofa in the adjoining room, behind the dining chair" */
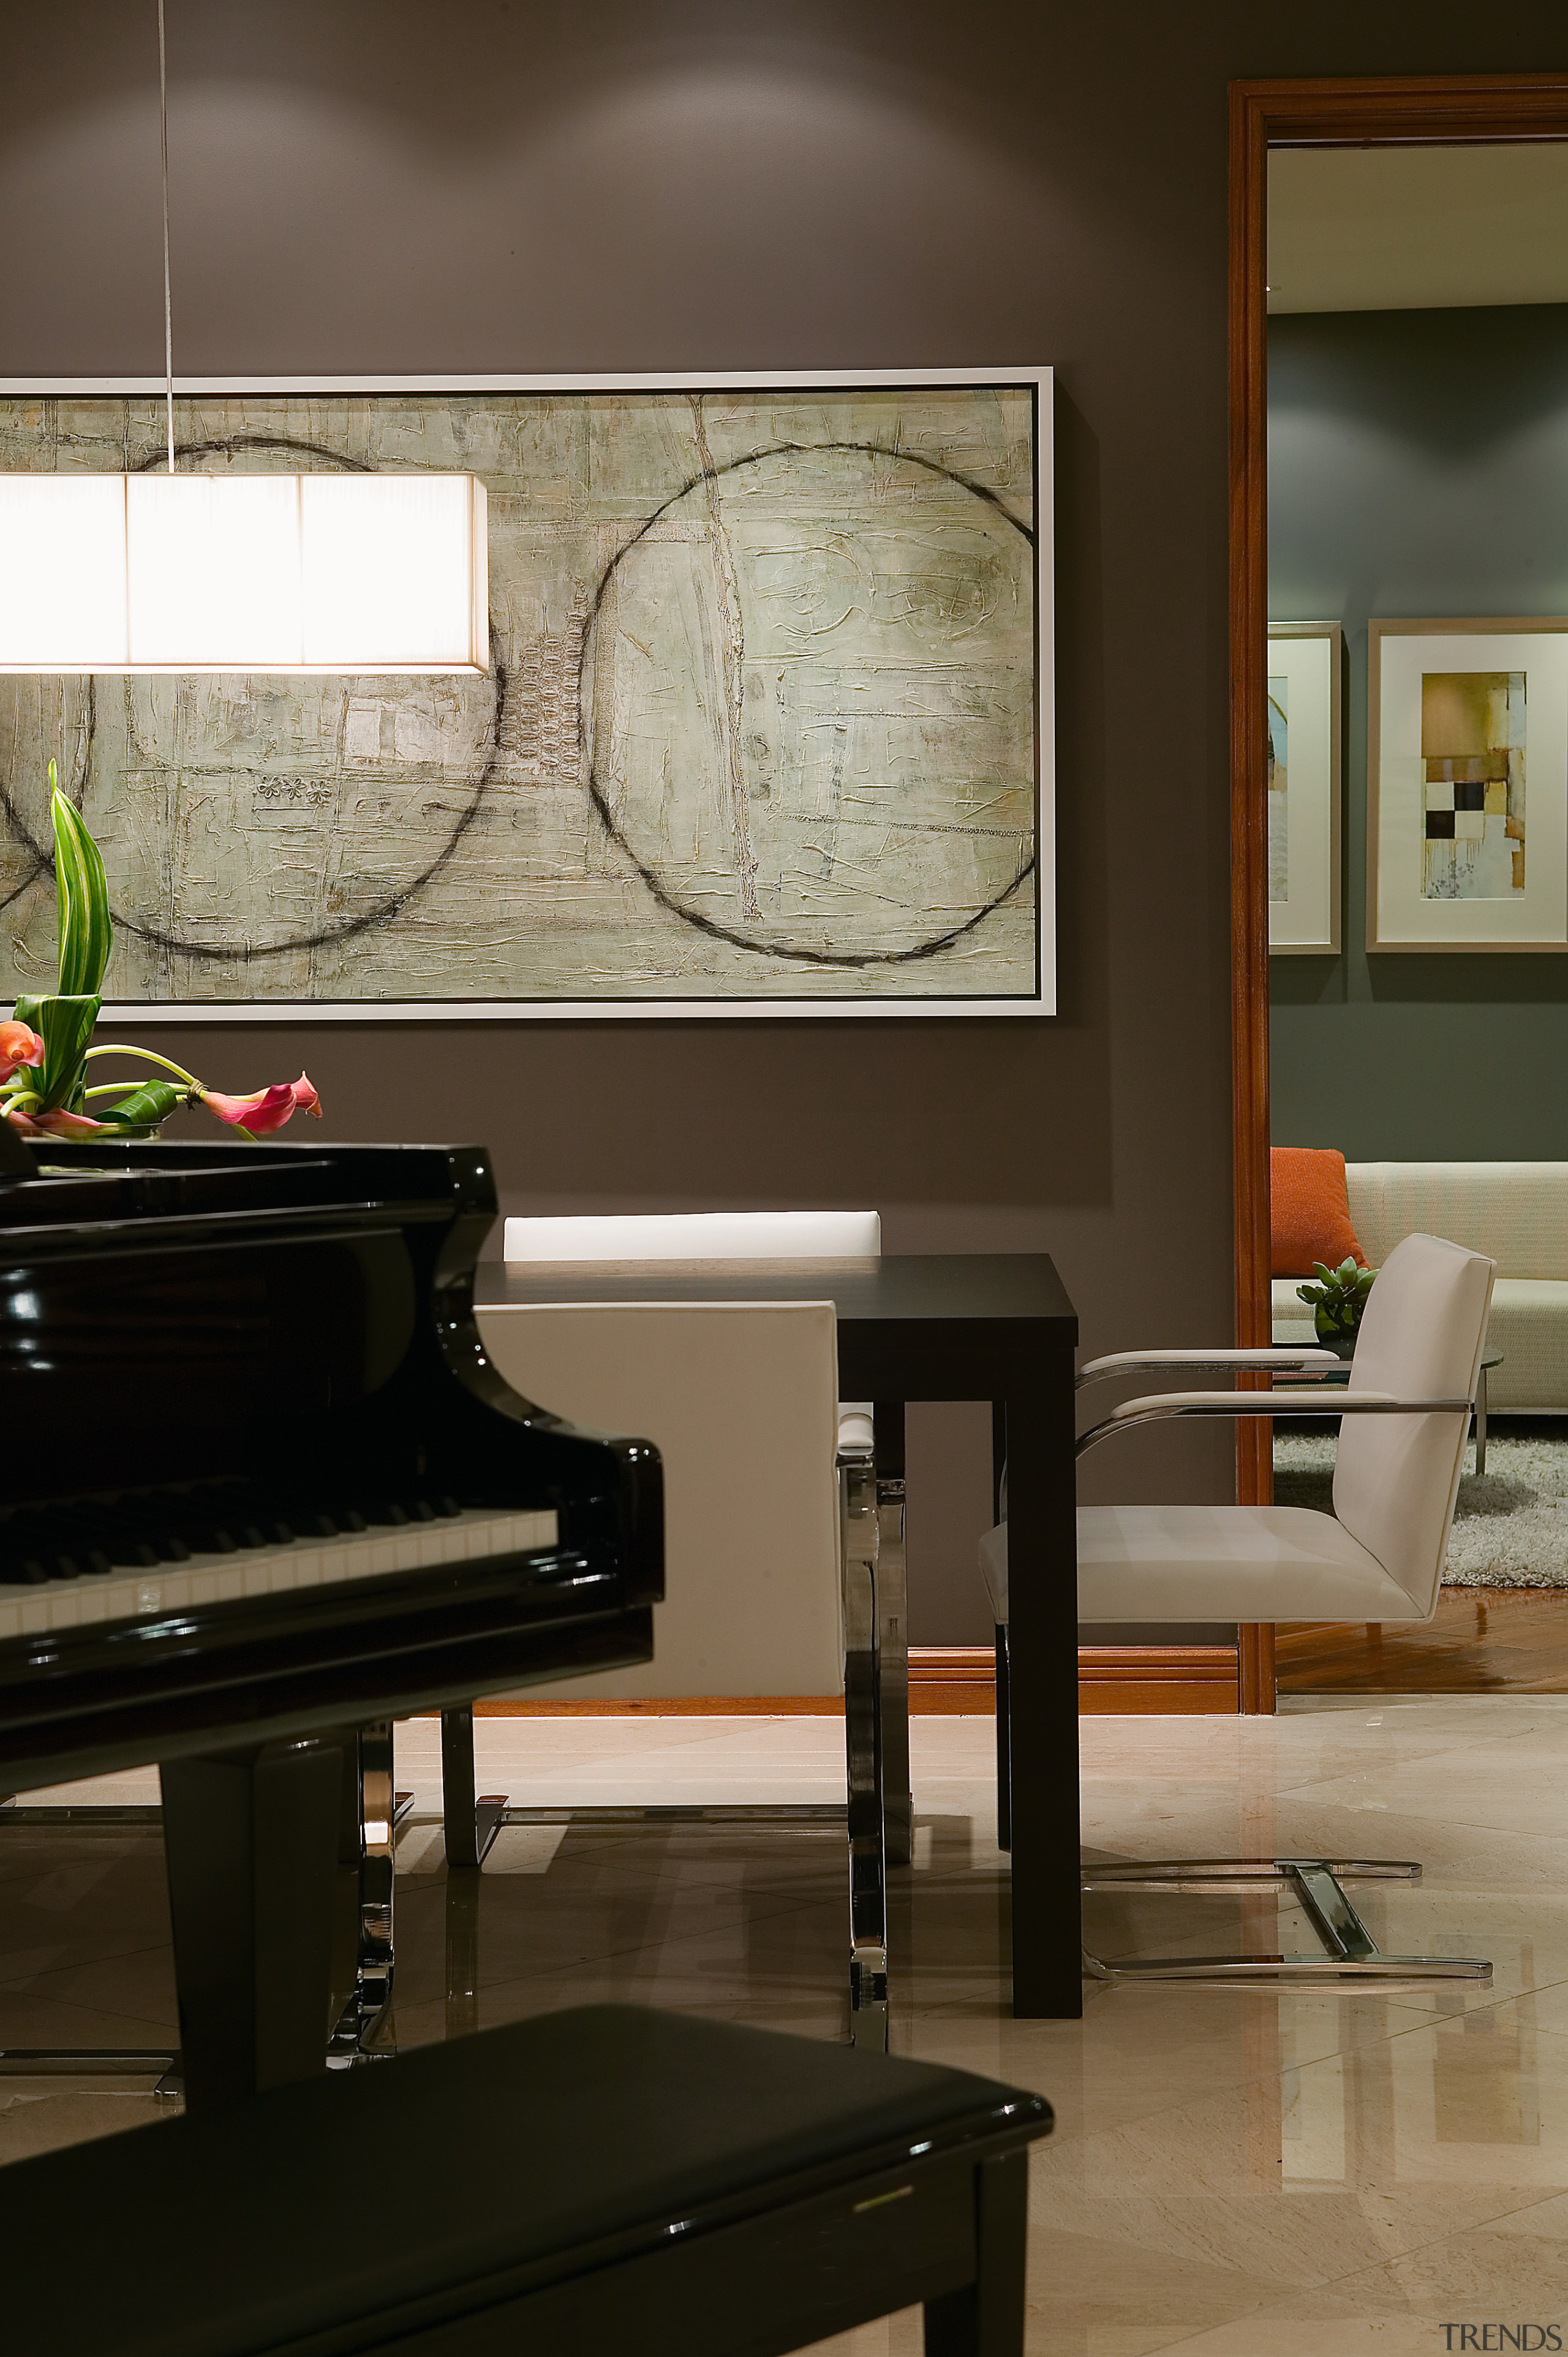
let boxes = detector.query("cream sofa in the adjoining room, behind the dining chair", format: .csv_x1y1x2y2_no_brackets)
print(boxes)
1273,1162,1568,1417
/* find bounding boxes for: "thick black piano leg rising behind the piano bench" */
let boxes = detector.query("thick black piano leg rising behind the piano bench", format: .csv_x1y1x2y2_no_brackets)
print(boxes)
158,1740,342,2112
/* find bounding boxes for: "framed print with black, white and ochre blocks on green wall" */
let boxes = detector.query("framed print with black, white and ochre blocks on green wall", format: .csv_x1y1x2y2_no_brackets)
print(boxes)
1368,615,1568,952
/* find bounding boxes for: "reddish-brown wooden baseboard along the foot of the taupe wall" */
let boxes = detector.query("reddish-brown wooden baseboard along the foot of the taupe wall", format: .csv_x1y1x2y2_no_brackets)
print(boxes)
474,1645,1240,1718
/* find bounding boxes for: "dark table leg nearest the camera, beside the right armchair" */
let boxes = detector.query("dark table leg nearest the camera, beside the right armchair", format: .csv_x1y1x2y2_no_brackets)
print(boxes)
1007,1351,1082,2020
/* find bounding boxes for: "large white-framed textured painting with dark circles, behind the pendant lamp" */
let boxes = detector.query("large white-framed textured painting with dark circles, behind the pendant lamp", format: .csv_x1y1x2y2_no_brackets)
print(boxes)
0,368,1057,1023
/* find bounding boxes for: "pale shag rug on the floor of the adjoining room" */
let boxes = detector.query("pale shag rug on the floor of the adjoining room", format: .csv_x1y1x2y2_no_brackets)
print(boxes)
1273,1417,1568,1589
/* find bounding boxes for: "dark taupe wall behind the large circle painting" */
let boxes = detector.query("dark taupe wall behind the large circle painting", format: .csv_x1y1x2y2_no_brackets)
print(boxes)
0,0,1561,1640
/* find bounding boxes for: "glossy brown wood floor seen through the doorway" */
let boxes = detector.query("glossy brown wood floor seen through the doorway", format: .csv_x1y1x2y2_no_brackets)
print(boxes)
1278,1589,1568,1695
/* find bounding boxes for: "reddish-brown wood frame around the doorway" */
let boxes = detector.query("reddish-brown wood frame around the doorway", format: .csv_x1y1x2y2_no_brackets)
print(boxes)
1229,73,1568,1711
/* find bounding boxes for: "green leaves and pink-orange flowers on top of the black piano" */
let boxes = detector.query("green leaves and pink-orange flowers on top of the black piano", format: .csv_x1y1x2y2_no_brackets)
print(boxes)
0,761,321,1139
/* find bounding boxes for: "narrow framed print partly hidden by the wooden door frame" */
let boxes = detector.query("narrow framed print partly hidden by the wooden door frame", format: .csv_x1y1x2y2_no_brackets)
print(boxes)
1266,622,1341,957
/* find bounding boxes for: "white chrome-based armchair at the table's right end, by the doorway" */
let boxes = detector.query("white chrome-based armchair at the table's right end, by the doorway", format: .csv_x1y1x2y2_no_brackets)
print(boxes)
981,1235,1495,1982
